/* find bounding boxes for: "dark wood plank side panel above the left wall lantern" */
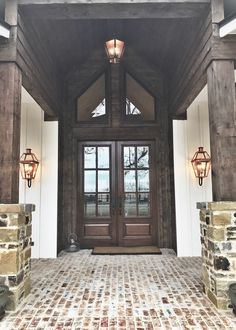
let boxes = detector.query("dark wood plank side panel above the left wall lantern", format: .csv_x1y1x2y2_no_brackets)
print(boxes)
16,15,62,116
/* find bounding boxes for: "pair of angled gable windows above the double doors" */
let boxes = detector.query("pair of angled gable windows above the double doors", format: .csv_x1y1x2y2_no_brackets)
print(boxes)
76,66,156,127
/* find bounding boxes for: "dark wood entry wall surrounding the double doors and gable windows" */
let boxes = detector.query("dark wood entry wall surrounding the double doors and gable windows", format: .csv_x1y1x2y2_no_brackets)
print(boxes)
58,56,176,250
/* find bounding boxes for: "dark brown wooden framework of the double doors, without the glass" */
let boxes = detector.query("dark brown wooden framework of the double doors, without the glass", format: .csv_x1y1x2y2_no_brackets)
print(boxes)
76,140,157,247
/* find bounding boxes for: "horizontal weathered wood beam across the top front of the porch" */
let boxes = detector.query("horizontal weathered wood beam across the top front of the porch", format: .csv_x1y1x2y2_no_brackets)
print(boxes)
19,0,210,20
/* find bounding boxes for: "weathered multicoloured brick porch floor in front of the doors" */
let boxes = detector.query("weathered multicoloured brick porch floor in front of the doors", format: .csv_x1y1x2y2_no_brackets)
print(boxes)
0,250,236,330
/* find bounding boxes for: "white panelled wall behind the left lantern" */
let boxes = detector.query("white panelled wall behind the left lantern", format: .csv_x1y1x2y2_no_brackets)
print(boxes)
19,88,58,258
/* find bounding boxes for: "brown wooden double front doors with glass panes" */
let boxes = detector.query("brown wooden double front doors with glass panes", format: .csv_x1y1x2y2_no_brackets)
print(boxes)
77,141,157,247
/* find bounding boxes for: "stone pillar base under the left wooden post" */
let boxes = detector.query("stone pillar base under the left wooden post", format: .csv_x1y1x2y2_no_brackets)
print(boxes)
0,204,35,310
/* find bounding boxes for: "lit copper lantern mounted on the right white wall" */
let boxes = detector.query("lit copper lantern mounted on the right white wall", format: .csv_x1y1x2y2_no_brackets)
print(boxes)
191,147,211,186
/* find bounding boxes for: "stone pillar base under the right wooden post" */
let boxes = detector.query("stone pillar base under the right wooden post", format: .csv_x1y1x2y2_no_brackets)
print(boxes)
197,202,236,309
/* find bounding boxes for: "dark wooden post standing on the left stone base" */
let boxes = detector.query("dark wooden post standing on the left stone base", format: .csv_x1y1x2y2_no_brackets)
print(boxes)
0,0,21,203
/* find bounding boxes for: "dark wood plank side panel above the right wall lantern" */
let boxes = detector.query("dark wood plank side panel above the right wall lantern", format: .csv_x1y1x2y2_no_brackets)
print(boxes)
169,10,212,118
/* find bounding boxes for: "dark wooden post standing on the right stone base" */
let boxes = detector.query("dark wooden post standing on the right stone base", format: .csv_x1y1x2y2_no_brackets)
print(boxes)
207,60,236,201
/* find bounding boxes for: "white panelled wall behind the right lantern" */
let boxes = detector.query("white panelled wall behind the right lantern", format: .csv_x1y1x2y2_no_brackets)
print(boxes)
173,87,212,256
